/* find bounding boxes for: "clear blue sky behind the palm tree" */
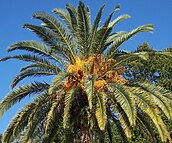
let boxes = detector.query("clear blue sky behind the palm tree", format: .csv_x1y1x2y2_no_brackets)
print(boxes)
0,0,172,133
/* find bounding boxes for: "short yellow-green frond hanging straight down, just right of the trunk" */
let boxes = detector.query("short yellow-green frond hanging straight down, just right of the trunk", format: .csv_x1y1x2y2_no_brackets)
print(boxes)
95,91,107,130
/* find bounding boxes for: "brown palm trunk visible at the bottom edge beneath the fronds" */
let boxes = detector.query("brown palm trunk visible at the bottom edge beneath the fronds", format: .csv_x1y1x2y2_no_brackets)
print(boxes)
80,128,93,143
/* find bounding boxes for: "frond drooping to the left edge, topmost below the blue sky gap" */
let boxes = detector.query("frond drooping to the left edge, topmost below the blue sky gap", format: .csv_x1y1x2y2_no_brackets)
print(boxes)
0,82,49,117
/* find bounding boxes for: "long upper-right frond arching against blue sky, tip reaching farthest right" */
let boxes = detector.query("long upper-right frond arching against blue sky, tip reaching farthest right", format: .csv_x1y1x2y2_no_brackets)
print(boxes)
107,24,153,58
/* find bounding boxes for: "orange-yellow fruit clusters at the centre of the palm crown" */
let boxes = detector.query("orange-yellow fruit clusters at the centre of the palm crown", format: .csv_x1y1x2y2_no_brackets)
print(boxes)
64,54,127,92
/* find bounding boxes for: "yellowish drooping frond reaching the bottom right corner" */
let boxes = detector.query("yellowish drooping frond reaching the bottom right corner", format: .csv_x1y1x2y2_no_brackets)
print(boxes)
130,87,171,141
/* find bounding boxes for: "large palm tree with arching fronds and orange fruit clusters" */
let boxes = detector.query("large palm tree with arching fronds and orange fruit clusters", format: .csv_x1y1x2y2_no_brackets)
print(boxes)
0,1,172,143
